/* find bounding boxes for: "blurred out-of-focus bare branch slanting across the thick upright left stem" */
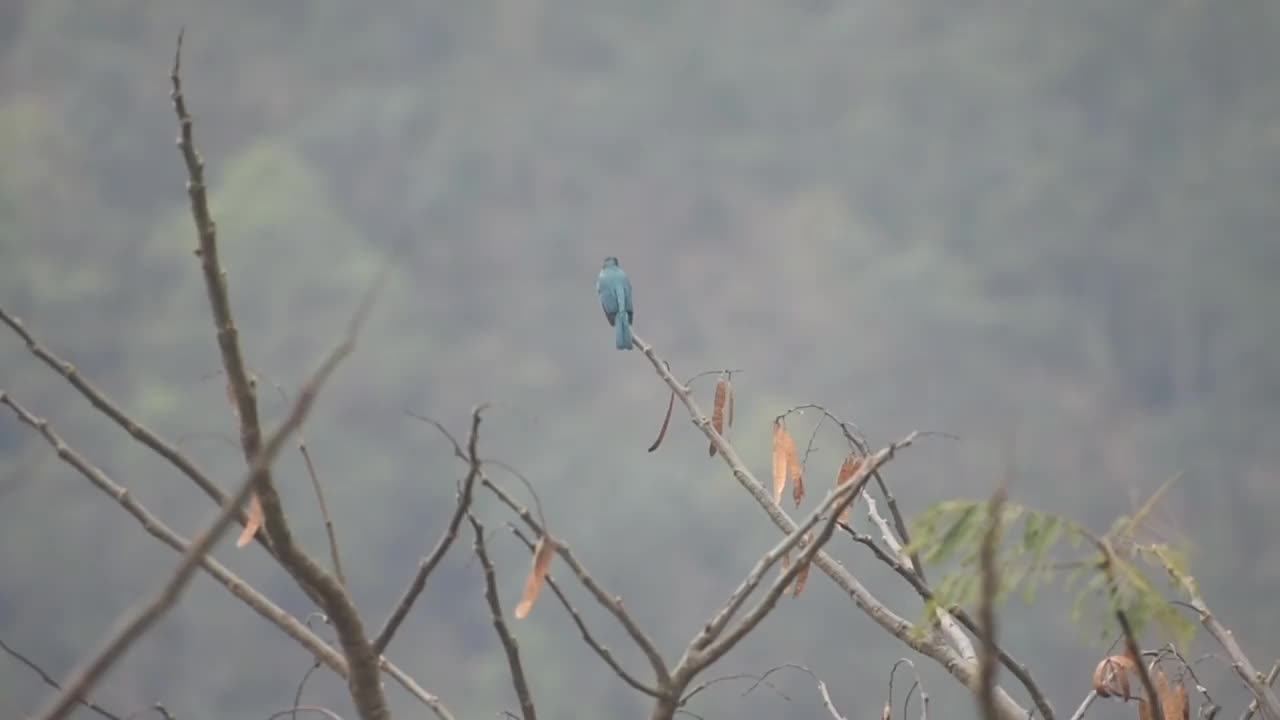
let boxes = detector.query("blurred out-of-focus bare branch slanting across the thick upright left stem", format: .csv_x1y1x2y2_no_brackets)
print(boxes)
30,317,358,720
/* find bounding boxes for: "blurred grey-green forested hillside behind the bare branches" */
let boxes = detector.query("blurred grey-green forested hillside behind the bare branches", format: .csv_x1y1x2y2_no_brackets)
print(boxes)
0,0,1280,719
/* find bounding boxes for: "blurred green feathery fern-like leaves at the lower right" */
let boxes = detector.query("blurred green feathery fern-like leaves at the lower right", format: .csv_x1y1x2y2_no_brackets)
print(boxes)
906,493,1196,647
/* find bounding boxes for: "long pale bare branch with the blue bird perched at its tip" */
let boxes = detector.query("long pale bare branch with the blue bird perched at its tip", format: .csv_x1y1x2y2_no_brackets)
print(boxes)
632,333,1027,720
